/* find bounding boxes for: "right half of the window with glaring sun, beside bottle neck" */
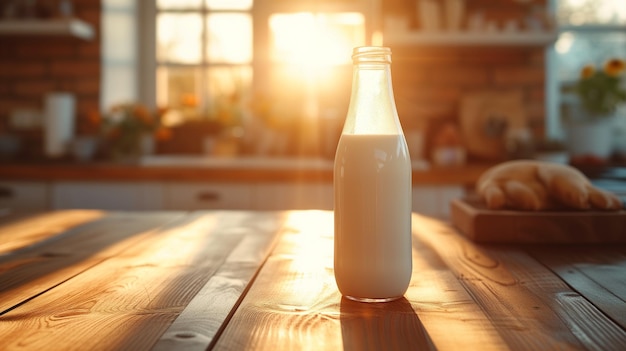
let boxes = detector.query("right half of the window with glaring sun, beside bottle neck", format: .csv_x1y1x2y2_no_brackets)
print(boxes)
264,12,365,119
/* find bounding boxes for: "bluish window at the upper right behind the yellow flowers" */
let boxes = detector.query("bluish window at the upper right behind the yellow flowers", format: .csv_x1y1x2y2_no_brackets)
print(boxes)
547,0,626,136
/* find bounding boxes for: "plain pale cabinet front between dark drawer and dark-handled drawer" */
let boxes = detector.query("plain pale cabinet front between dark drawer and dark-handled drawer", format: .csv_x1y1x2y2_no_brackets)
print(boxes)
52,181,163,211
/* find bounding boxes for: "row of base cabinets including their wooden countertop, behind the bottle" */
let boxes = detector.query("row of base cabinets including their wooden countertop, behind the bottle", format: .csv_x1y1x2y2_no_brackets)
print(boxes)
0,160,476,217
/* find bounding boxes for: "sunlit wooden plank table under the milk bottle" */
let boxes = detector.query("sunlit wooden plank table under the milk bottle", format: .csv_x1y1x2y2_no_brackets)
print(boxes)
0,210,626,350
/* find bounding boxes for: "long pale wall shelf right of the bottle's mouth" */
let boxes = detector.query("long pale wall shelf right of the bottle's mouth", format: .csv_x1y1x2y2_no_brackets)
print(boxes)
384,31,557,46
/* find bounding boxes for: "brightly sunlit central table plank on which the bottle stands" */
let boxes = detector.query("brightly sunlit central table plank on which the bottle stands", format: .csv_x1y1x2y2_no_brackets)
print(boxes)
211,211,506,350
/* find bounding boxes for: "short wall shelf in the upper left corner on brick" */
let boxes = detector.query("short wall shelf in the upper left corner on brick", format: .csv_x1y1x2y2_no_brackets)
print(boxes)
0,18,94,40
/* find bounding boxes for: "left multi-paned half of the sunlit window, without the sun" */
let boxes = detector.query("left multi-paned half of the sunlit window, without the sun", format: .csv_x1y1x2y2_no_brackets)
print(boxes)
155,0,253,123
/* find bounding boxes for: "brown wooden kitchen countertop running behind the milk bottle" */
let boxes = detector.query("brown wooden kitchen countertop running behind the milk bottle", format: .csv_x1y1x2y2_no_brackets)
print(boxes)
0,156,491,185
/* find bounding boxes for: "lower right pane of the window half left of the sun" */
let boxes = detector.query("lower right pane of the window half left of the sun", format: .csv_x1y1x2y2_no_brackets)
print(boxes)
206,66,252,125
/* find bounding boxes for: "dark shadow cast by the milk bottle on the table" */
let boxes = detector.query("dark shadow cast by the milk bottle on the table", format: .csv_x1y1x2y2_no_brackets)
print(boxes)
340,297,436,351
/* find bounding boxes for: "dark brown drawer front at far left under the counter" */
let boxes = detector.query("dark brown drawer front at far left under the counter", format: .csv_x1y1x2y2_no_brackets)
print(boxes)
0,181,50,214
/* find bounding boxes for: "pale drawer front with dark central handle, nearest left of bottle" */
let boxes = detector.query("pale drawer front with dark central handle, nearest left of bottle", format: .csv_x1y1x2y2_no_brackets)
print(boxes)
163,182,254,211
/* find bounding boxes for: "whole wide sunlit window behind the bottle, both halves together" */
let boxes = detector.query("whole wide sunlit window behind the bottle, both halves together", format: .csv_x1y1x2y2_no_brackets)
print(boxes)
133,0,370,133
